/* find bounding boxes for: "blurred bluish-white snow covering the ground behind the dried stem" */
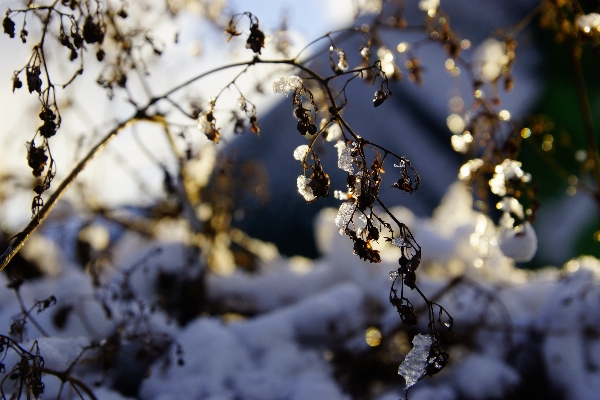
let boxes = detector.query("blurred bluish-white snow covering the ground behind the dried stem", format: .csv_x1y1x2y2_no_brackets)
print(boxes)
0,182,600,400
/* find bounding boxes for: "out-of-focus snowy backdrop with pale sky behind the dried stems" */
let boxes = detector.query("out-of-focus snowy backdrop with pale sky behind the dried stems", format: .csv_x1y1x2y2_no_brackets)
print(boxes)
0,0,600,400
